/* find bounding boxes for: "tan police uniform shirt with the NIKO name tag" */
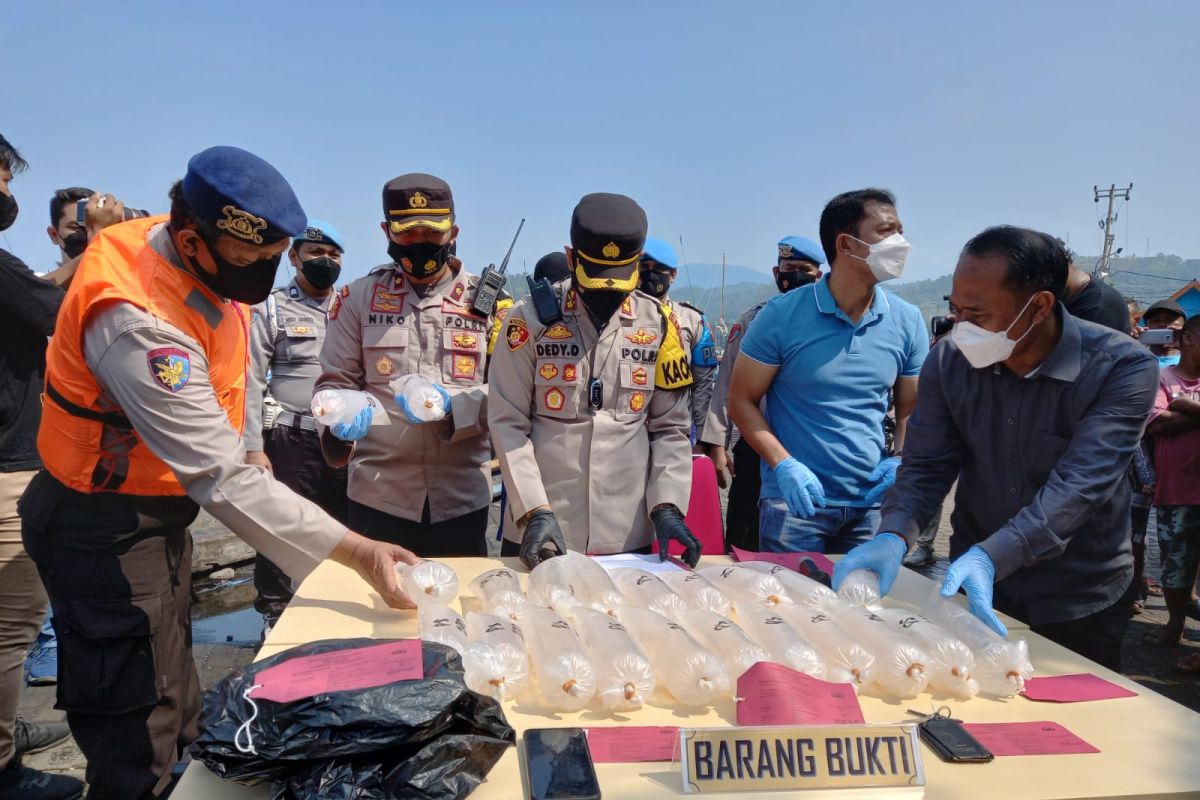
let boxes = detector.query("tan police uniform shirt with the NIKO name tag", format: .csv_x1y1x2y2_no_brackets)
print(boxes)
314,258,492,523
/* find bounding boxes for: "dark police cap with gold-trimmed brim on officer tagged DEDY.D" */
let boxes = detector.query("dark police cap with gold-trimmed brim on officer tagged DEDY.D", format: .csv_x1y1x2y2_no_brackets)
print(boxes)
571,192,647,291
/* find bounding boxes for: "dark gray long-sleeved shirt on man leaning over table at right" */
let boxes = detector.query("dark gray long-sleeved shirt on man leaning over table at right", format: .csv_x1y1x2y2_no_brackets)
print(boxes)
880,306,1158,625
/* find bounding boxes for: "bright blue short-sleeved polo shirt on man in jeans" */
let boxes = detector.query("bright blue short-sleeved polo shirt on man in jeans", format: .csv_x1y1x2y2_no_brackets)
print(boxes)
740,278,929,507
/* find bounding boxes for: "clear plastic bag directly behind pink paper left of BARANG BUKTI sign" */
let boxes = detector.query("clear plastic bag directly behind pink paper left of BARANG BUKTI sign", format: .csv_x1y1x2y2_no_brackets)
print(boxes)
575,606,656,711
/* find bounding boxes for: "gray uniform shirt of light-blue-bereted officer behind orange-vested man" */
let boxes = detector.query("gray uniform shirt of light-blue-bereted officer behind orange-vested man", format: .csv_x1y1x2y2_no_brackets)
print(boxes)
242,278,335,451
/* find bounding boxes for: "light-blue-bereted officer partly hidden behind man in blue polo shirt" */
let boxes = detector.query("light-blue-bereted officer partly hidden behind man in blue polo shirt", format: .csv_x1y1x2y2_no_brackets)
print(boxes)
700,236,824,551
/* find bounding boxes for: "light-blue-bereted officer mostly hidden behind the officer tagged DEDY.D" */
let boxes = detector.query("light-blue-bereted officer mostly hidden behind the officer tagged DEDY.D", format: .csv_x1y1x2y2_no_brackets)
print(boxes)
637,239,718,441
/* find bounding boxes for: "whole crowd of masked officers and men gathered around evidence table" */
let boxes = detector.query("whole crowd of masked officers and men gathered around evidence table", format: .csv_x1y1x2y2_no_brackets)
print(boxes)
0,137,1200,800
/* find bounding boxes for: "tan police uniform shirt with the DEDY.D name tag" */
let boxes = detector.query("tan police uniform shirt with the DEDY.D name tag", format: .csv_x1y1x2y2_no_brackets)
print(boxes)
487,281,691,553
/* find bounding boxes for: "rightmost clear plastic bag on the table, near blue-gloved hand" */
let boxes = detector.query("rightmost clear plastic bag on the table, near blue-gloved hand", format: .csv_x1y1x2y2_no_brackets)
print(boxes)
923,585,1033,697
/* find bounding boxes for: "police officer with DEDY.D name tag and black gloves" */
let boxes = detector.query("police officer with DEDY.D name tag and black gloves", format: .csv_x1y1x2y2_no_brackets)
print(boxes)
487,194,700,569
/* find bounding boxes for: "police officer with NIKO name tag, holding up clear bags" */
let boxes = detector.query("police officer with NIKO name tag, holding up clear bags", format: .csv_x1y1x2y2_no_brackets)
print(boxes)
317,173,500,557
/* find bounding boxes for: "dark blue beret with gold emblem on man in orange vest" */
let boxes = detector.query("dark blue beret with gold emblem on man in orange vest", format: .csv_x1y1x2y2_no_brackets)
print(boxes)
184,146,307,245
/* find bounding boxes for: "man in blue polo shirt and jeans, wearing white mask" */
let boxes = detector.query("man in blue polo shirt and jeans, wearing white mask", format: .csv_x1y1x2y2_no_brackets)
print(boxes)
730,188,929,553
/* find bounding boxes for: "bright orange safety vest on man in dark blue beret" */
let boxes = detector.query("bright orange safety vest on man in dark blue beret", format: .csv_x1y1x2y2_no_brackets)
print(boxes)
37,216,250,495
